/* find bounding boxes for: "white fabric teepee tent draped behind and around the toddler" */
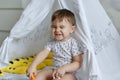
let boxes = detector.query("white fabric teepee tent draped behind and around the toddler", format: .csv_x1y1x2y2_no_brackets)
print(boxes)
0,0,120,80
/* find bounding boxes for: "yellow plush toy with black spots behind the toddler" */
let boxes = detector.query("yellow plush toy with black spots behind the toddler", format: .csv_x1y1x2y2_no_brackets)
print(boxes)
1,52,53,74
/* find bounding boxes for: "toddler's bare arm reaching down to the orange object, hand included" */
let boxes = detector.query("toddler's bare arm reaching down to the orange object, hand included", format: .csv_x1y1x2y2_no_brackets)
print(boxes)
27,49,49,78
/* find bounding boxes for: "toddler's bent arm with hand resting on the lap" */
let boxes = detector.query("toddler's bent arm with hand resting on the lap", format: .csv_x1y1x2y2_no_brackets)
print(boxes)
53,54,82,78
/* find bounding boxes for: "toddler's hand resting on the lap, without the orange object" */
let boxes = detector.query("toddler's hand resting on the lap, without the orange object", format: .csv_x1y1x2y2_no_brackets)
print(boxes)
53,67,65,79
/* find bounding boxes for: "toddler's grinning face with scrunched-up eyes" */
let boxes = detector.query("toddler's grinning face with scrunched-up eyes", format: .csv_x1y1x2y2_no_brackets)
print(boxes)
51,19,75,41
